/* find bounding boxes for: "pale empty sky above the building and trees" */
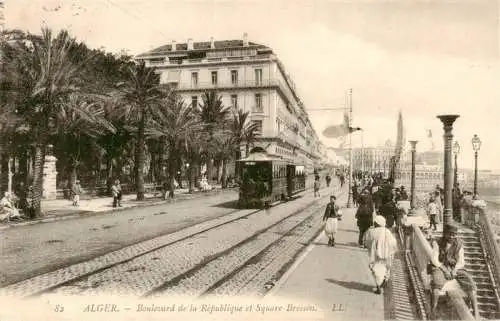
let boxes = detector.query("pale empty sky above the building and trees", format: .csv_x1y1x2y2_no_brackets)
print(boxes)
5,0,500,169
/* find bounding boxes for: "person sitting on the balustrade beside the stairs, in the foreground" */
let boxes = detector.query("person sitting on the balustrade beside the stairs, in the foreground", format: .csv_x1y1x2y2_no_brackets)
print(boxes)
429,223,478,319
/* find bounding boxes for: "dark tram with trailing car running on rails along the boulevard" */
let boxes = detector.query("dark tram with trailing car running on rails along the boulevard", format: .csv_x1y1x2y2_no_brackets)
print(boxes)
238,149,306,208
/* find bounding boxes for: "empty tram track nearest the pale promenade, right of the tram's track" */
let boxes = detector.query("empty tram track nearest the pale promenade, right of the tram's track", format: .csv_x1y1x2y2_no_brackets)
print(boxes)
148,190,344,298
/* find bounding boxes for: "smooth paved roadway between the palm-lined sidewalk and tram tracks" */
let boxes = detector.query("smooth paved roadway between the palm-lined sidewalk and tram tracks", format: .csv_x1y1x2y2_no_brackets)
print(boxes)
0,191,238,286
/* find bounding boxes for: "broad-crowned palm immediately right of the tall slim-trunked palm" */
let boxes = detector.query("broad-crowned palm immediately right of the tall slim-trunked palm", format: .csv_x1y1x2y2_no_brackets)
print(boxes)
147,93,203,197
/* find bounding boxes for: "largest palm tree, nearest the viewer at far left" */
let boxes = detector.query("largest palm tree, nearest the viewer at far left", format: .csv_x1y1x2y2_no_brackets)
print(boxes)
9,29,91,216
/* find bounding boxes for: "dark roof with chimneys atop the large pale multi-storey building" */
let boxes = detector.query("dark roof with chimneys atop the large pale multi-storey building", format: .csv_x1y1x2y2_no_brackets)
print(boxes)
137,40,271,58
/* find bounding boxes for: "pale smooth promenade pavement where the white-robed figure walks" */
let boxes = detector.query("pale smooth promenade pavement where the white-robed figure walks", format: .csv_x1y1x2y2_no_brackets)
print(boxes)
268,208,386,320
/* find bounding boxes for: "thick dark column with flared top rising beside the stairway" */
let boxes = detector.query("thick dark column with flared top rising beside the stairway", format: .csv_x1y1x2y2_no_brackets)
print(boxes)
437,115,460,233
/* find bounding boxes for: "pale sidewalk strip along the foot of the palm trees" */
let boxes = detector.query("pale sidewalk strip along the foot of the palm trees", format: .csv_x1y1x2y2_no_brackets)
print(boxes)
0,185,231,230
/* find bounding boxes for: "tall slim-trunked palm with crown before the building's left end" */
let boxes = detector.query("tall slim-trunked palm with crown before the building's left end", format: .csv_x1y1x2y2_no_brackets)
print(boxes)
119,62,167,201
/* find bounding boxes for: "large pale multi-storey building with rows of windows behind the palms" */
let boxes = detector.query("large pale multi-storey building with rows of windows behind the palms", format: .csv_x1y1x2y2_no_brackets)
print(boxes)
136,34,326,172
